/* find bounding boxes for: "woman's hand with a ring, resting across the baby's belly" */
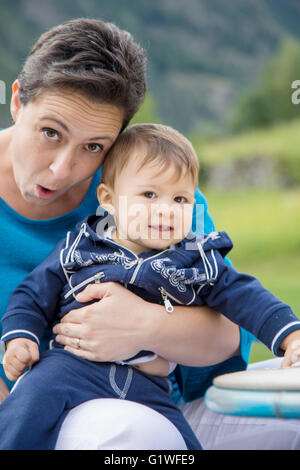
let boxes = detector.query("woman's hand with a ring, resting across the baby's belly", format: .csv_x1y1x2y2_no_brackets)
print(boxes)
53,282,161,362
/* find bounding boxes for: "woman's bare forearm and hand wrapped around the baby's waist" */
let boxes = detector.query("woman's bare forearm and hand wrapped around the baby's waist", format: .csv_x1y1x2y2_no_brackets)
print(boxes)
54,282,240,366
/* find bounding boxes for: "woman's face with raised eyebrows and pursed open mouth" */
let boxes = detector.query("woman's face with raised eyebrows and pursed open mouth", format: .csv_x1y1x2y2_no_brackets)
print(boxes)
11,90,123,206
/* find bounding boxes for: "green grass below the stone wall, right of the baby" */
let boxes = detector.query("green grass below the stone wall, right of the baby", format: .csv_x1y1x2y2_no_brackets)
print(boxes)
202,188,300,362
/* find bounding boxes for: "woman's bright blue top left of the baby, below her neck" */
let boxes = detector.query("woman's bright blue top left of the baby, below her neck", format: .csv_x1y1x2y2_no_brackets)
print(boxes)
0,167,102,387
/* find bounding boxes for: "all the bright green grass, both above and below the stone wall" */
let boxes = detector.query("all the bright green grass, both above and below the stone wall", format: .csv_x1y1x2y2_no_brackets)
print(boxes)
193,119,300,362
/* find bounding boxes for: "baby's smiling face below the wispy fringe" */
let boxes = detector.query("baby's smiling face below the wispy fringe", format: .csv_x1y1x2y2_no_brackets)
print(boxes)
113,156,195,253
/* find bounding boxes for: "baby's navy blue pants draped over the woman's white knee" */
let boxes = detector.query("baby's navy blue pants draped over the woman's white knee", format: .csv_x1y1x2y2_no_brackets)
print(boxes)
0,349,201,450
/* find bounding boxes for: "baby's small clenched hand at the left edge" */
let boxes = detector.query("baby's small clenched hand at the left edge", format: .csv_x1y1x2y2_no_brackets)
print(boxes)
3,338,40,381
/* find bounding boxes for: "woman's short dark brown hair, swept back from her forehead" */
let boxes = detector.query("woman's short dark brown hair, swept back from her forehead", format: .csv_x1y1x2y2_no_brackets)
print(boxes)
18,18,146,128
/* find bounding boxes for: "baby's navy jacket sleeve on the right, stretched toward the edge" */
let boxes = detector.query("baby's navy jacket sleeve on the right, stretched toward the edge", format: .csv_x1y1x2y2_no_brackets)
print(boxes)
197,250,300,356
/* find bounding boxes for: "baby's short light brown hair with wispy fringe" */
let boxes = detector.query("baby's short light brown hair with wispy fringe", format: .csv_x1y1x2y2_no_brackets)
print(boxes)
101,124,199,189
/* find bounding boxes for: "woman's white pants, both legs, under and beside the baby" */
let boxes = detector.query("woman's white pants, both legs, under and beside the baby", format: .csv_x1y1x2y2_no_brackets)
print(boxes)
56,359,300,450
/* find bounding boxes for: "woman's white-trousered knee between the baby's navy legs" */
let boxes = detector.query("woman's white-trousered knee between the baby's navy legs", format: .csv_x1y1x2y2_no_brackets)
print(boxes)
56,398,186,450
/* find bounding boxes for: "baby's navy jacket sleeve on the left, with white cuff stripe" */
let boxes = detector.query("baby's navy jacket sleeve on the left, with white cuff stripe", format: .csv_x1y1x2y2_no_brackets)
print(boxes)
1,240,66,344
